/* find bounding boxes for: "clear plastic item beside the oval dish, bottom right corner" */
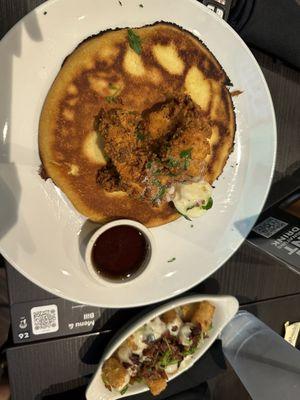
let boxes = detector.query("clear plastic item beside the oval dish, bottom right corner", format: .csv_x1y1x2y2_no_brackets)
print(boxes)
221,311,300,400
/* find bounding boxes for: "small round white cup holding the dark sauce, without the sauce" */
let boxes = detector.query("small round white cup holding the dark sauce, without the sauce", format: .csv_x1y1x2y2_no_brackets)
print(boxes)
85,219,155,287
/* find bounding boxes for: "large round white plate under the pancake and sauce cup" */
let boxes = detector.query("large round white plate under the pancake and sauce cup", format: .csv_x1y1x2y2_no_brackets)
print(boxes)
0,0,276,307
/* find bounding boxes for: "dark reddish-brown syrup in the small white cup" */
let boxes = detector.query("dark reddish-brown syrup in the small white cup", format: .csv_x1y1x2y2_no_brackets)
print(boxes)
92,225,150,281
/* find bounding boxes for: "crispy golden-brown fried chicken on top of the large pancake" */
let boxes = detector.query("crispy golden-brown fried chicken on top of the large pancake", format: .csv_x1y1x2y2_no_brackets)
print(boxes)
96,95,212,205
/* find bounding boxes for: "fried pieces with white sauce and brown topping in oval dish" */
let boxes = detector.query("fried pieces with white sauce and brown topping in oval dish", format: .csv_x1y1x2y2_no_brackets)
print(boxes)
102,300,215,396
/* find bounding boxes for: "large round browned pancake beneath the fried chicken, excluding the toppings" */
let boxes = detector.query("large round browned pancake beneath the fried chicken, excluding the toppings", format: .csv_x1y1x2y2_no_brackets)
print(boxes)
39,22,235,226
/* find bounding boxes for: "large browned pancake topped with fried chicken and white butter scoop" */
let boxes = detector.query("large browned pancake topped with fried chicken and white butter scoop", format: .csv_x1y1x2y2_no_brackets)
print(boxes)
39,22,235,227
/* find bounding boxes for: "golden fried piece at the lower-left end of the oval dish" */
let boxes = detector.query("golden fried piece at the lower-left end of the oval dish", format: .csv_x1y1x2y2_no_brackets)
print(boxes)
102,357,130,390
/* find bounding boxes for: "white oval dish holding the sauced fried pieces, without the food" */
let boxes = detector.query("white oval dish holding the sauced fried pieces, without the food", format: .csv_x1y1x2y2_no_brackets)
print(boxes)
86,295,239,400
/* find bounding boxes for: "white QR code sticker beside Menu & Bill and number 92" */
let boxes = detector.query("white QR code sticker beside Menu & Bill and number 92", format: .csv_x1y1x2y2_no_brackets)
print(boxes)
30,304,59,335
